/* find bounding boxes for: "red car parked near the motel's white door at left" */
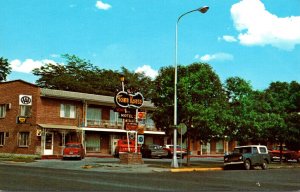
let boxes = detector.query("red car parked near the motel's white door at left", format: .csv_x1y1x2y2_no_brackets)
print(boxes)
63,142,85,160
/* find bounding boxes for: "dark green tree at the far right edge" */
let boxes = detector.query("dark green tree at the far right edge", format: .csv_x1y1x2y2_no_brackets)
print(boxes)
265,81,300,161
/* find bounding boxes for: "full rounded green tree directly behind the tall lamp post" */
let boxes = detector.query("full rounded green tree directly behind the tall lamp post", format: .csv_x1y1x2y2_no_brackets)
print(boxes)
152,63,226,163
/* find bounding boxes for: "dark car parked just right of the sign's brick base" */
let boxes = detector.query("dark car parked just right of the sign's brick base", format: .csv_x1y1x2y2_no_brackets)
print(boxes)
141,144,168,158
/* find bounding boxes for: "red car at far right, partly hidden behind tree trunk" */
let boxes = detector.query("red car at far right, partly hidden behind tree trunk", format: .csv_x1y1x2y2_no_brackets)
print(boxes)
269,145,300,162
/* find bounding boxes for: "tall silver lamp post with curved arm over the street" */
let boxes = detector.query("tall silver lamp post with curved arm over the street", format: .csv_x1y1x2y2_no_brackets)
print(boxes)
171,6,209,168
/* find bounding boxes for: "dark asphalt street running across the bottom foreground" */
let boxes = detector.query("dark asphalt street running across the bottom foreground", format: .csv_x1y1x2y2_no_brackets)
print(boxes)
0,164,300,192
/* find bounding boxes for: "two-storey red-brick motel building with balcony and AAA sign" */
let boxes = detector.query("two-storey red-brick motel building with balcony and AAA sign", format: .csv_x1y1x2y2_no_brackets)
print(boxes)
0,80,233,157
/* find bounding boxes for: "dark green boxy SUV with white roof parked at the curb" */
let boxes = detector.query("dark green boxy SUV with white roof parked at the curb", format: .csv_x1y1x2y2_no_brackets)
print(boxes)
224,145,271,170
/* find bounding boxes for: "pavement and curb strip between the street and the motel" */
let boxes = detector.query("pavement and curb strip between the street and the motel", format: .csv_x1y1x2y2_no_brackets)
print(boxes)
0,157,223,173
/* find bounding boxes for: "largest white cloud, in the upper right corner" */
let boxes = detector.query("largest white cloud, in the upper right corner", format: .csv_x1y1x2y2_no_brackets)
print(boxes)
231,0,300,50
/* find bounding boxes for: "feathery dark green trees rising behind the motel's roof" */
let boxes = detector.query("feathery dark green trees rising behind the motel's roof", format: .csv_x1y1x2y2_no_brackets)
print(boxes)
33,54,152,99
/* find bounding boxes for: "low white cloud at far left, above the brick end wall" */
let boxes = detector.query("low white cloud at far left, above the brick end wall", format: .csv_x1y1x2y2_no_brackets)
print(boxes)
10,59,56,73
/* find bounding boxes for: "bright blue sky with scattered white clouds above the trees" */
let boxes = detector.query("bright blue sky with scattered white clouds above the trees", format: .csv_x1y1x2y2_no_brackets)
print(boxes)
0,0,300,90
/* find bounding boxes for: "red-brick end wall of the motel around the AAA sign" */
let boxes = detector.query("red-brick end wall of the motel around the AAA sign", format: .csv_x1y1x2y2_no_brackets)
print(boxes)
0,81,40,154
